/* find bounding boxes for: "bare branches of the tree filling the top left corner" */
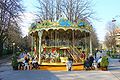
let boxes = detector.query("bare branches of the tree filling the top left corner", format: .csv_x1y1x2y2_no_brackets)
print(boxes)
0,0,23,52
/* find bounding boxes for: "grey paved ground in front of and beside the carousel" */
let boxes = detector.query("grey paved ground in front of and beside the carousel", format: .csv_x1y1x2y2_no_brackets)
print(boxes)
0,59,120,80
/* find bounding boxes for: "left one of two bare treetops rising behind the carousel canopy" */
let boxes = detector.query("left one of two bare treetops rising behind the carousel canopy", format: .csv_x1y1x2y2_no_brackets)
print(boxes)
37,0,55,21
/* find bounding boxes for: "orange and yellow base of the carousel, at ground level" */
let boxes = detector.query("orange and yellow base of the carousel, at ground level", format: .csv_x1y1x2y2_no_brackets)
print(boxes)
39,63,84,71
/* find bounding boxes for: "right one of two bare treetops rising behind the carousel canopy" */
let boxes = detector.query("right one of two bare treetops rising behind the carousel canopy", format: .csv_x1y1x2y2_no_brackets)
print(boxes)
62,0,94,22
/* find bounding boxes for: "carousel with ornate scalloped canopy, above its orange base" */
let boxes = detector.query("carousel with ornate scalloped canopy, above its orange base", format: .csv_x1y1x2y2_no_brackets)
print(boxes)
29,18,92,70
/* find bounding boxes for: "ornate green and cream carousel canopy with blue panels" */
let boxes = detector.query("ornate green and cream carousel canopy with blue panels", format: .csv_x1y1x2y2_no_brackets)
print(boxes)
29,18,92,33
